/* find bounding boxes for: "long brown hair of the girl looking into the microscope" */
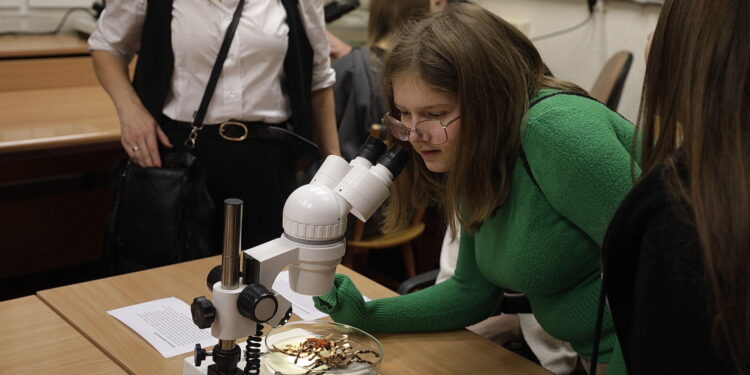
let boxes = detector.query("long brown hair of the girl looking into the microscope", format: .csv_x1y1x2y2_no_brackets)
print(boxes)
382,4,585,233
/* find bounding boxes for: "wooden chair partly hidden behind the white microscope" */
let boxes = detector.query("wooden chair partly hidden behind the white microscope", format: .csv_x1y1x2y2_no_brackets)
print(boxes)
343,124,425,278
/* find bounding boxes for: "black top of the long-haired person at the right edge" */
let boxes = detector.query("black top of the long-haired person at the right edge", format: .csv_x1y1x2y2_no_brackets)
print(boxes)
602,168,734,375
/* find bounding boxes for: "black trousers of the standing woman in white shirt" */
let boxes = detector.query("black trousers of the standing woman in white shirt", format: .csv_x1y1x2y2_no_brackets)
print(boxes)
161,118,297,254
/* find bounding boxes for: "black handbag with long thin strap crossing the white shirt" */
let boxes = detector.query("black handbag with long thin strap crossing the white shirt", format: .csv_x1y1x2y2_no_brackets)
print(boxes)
105,0,245,274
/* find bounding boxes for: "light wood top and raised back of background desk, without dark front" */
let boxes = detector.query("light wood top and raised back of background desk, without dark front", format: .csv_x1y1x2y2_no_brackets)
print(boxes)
0,34,120,154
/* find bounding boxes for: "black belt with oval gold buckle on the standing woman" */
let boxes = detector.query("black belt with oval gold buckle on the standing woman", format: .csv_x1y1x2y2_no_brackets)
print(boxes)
162,117,318,153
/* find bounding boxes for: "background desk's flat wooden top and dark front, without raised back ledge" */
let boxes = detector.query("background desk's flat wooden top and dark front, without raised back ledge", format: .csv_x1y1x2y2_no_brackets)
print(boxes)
0,86,124,284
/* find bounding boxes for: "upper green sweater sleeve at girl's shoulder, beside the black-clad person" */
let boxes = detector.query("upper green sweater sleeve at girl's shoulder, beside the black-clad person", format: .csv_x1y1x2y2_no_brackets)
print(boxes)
522,95,640,246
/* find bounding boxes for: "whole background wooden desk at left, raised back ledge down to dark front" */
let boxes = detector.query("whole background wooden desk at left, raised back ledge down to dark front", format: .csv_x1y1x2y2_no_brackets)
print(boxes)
0,34,125,298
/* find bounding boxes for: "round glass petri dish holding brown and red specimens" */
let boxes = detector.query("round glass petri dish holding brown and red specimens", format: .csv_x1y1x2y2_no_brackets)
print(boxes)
263,321,384,375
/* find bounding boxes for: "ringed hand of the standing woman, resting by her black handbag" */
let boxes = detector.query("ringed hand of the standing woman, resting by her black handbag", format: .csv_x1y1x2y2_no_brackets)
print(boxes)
117,103,173,167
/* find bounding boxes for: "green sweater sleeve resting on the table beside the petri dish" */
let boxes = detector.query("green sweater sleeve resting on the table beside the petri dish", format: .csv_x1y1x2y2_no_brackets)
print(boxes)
314,234,502,332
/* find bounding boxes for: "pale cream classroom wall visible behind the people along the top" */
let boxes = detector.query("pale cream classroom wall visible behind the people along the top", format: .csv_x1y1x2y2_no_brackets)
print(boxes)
0,0,660,121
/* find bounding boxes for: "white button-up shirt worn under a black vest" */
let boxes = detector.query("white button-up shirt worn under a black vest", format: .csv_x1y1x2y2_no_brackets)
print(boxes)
89,0,336,124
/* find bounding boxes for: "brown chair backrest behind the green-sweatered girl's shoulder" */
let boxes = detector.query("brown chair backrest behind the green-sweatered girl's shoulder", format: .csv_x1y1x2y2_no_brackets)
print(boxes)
589,51,633,111
